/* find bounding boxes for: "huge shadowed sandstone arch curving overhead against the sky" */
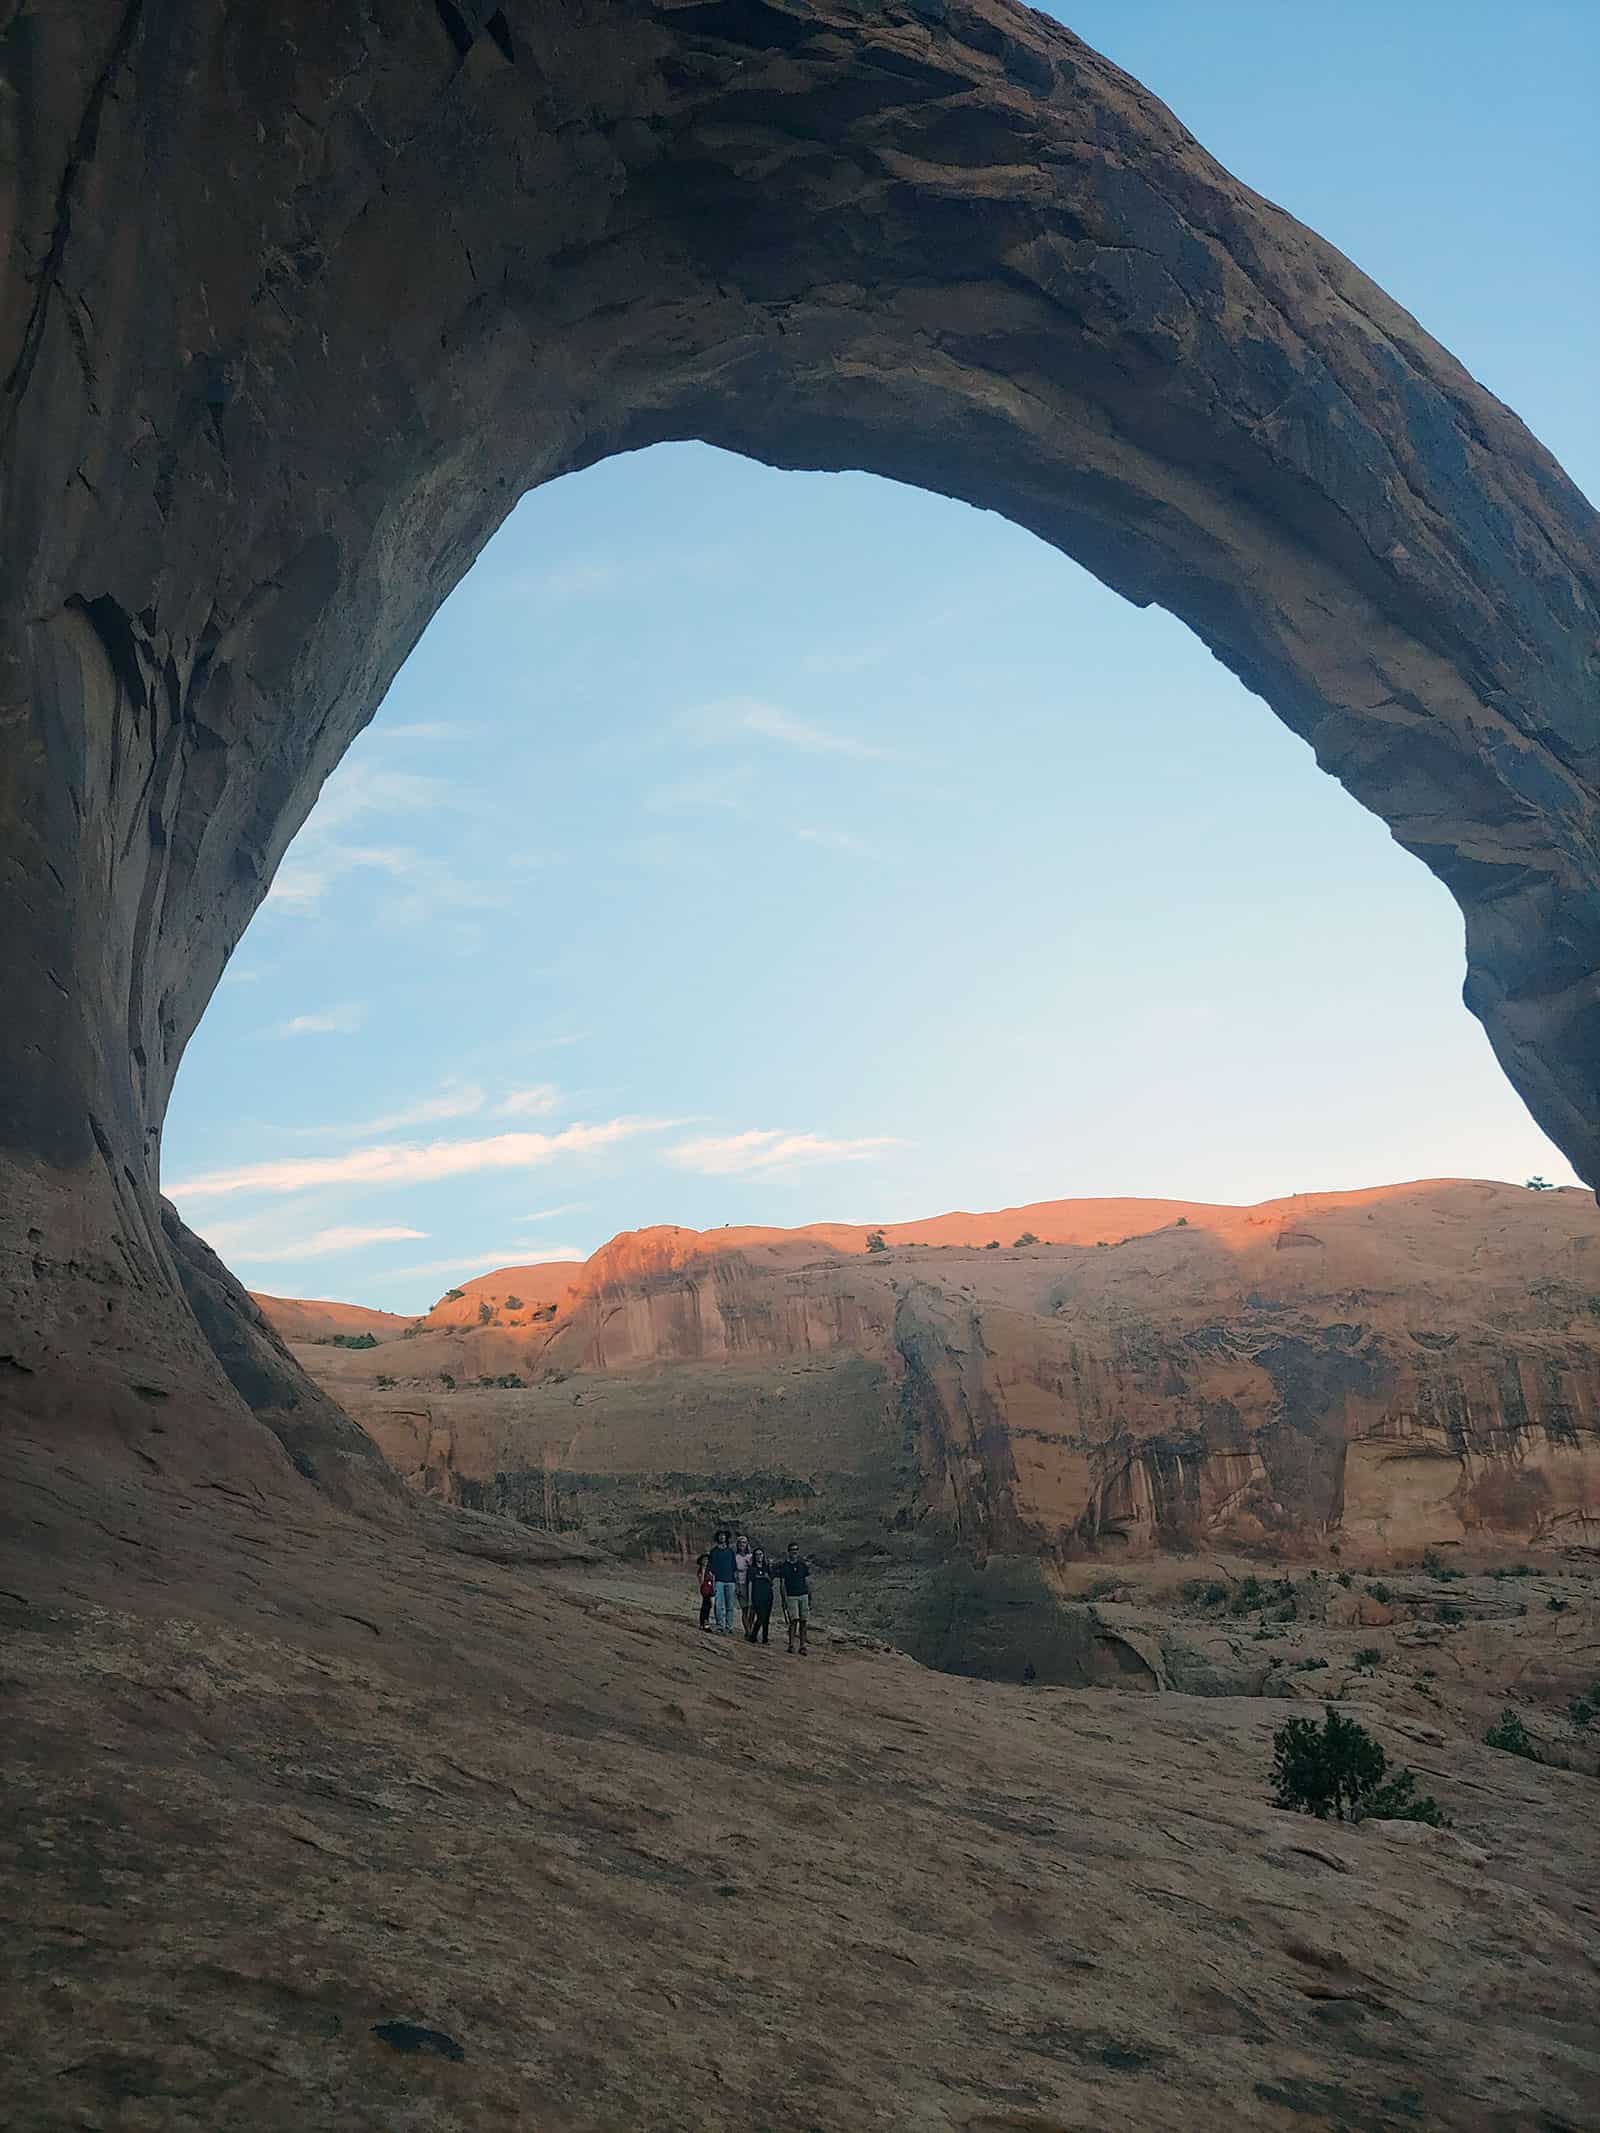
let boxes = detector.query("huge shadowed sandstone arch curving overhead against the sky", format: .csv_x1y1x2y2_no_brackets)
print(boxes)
0,0,1600,1472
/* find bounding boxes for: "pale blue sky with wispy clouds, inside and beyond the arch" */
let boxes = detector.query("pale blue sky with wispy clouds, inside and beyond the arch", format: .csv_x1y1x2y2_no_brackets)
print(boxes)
164,0,1600,1310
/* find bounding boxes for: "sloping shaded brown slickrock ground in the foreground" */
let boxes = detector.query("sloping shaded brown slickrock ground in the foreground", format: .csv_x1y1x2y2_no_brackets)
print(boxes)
0,1476,1600,2133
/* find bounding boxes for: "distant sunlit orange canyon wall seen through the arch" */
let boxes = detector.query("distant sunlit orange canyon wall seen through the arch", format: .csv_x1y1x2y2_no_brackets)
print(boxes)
267,1182,1600,1563
